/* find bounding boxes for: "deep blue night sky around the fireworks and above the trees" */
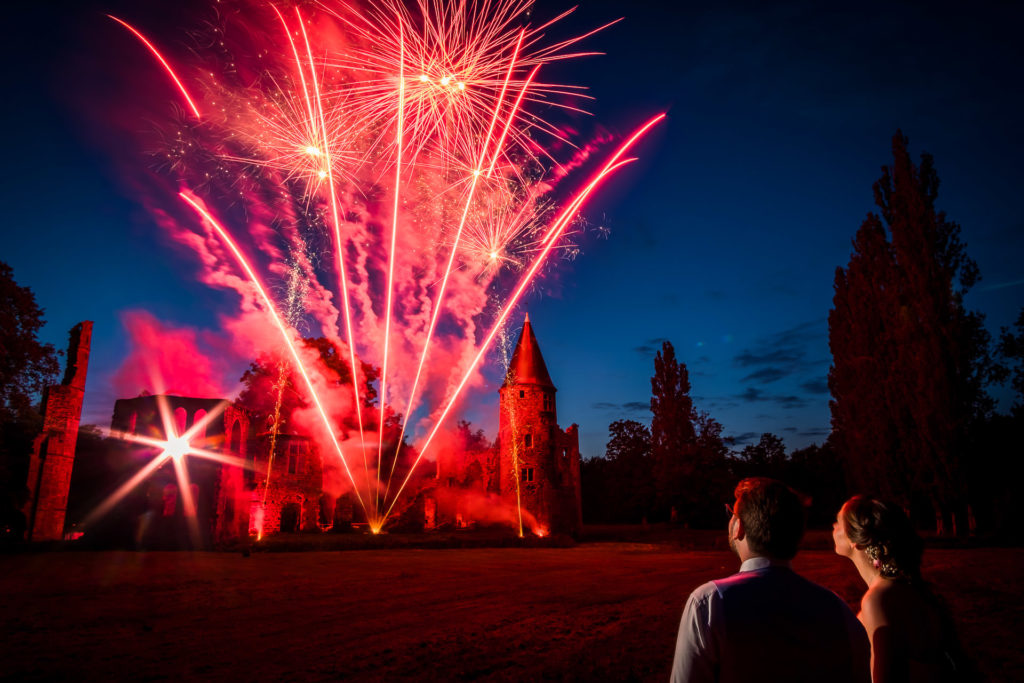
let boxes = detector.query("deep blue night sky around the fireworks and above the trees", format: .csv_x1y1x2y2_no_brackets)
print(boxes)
0,0,1024,457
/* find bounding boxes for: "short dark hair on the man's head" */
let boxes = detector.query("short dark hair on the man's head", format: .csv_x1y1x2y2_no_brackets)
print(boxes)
733,477,806,560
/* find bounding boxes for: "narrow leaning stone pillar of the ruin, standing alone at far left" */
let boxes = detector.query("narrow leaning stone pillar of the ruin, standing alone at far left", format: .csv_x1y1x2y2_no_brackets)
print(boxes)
25,321,92,541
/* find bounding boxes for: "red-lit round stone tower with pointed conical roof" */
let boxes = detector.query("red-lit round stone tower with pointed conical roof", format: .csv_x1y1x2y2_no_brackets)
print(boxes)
499,315,582,533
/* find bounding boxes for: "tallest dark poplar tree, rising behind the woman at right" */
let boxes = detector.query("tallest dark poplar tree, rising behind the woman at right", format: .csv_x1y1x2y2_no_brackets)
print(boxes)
828,132,991,530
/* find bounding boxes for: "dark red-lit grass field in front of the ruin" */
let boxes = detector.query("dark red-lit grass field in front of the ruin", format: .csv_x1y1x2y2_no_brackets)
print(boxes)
0,543,1024,681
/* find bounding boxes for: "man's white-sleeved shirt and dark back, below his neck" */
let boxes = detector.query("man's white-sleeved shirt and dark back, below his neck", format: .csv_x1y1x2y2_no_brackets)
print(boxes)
672,557,871,683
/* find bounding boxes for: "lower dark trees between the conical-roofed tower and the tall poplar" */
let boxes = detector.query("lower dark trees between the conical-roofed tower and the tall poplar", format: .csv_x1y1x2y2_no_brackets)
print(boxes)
581,342,847,528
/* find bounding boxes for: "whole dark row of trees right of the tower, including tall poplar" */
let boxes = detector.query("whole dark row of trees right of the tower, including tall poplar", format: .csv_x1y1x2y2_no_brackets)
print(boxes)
582,133,1024,539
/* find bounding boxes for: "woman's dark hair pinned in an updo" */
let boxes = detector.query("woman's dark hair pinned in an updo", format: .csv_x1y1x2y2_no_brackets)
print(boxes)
842,496,924,580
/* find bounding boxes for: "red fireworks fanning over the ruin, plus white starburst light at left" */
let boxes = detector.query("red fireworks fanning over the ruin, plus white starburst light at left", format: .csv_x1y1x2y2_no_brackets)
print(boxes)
99,0,662,531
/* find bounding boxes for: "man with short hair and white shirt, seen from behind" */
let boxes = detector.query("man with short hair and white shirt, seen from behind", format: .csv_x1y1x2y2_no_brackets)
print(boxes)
672,477,871,683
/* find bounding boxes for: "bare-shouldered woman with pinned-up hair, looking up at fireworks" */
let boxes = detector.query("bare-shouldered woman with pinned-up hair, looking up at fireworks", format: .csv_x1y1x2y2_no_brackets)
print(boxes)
833,496,976,683
